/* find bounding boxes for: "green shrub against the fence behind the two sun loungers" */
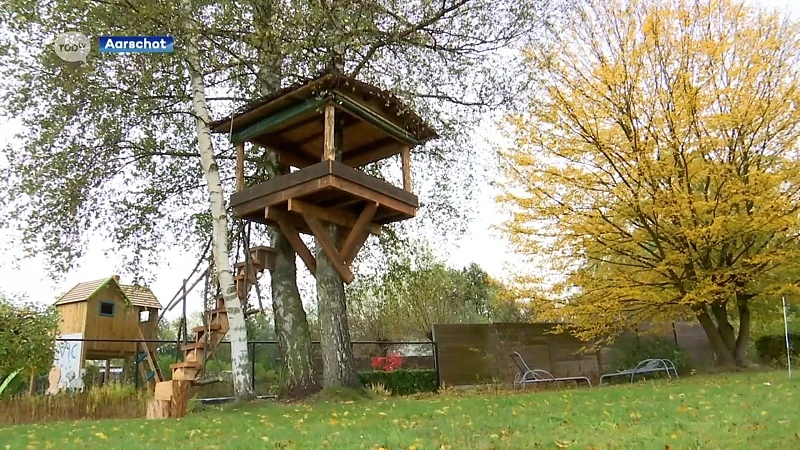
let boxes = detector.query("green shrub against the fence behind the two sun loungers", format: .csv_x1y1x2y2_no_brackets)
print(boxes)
603,335,693,375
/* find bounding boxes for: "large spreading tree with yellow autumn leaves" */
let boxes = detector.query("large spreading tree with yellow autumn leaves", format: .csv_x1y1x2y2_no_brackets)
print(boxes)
500,0,800,366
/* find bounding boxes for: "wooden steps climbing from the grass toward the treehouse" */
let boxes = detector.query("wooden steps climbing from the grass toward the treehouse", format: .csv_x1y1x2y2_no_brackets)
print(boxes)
147,246,275,419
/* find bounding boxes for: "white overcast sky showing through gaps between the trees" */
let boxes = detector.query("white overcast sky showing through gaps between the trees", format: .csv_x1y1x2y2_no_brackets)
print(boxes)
0,0,800,324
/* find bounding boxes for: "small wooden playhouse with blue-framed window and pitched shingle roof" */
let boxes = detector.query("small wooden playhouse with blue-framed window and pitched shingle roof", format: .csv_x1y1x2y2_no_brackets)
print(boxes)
49,275,161,388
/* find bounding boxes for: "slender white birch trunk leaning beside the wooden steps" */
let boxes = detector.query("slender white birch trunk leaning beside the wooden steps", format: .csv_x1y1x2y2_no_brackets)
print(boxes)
183,0,253,400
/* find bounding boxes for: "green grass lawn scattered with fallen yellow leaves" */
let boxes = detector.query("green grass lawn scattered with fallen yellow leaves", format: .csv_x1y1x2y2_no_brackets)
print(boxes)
0,372,800,450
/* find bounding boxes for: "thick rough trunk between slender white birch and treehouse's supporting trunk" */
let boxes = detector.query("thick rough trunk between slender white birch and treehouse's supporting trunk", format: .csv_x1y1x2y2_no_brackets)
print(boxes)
270,227,320,399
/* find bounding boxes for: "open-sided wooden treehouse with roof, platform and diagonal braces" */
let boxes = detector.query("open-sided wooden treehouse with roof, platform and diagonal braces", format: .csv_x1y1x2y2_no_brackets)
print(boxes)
212,74,438,283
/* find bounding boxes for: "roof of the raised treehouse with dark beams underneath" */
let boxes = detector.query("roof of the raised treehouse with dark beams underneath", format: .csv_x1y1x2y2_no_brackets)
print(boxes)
211,73,439,167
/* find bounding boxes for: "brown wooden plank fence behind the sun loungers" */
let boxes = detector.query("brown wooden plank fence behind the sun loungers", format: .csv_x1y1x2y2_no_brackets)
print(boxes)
434,323,711,386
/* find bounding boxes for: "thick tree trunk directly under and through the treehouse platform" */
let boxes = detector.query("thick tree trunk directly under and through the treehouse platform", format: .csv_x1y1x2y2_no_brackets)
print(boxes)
316,114,359,387
